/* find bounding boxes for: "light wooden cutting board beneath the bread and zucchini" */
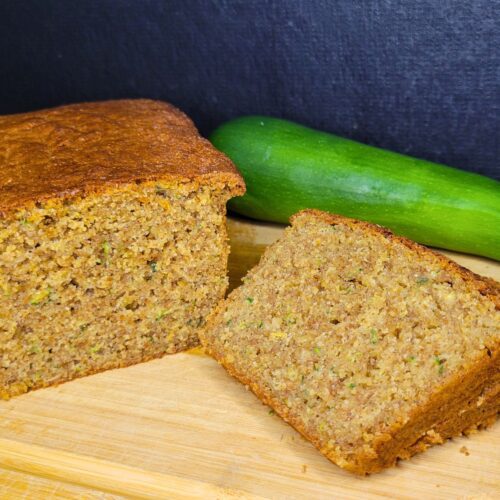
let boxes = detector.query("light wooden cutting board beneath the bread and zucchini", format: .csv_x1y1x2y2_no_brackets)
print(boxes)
0,219,500,499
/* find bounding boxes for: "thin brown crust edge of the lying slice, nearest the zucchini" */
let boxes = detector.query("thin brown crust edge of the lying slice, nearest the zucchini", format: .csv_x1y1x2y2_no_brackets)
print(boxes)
290,209,500,309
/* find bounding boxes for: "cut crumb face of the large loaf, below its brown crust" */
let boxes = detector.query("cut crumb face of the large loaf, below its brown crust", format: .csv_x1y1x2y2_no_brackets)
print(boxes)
0,179,232,398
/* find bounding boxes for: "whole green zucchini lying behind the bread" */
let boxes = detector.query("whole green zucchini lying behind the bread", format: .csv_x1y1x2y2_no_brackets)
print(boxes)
210,116,500,260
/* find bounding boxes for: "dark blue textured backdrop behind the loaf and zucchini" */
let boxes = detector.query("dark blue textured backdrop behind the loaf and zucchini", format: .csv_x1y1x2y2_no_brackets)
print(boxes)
0,0,500,178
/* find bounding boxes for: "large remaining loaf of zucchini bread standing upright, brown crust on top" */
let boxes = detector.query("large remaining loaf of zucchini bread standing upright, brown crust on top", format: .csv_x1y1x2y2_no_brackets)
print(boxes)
0,100,244,398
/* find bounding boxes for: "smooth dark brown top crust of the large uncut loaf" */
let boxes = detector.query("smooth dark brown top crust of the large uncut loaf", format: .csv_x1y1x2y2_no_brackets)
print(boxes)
0,99,245,215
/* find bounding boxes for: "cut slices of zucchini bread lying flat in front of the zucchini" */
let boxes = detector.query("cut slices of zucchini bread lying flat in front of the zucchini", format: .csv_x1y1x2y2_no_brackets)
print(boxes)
200,211,500,474
